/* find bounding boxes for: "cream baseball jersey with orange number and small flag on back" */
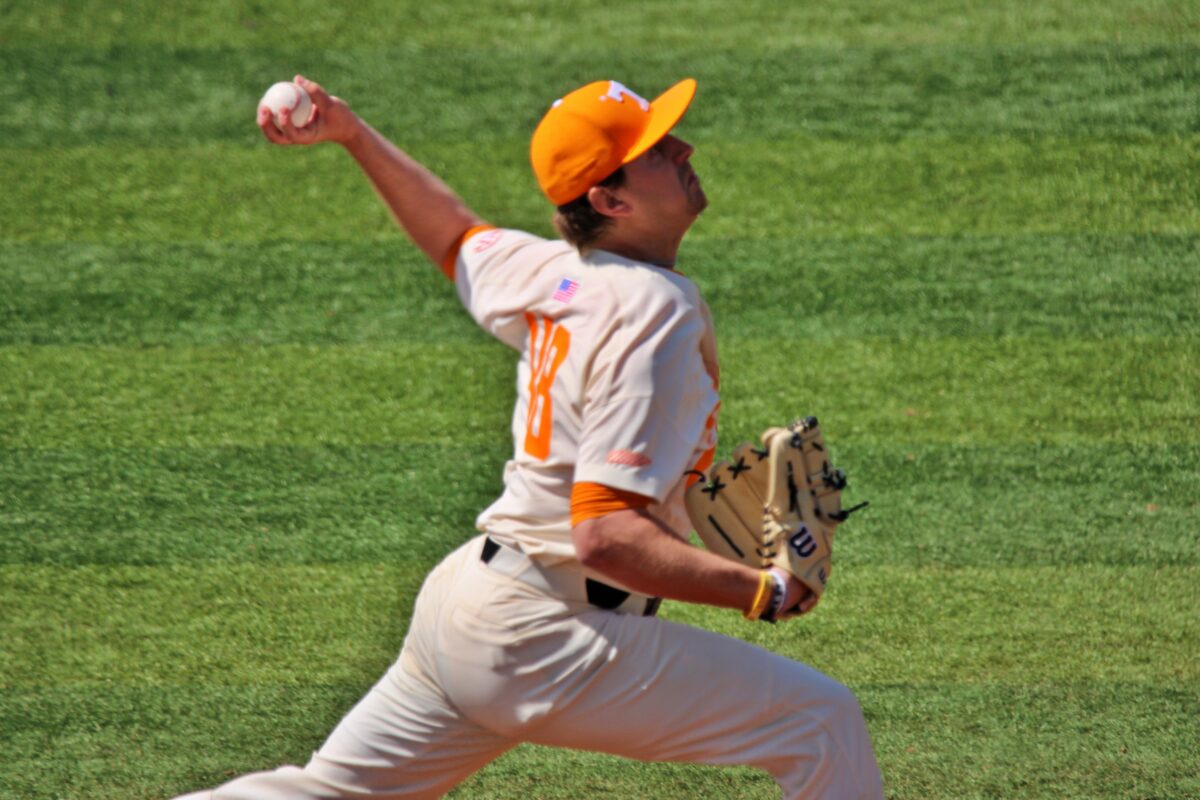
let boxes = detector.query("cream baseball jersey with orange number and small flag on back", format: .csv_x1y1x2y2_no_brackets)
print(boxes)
454,228,718,563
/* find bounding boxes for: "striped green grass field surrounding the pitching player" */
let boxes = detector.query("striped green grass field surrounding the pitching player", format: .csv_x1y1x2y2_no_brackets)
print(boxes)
0,0,1200,800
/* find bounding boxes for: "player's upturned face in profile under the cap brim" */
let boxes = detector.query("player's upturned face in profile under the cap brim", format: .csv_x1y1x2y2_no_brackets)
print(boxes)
623,133,708,225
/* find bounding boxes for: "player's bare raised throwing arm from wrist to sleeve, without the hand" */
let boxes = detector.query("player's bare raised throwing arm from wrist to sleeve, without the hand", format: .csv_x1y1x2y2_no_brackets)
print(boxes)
342,119,481,264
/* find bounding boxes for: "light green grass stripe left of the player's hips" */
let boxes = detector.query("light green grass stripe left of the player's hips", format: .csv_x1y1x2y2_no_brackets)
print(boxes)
0,563,422,686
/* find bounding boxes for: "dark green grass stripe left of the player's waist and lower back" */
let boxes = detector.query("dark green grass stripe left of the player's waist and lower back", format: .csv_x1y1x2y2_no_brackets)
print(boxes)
0,437,511,567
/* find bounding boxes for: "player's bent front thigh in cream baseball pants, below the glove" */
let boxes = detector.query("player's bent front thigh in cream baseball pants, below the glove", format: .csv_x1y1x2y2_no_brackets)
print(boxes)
530,613,870,774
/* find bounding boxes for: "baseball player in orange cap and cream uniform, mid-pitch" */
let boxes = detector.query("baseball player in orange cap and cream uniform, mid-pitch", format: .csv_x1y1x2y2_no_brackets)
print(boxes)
171,77,882,800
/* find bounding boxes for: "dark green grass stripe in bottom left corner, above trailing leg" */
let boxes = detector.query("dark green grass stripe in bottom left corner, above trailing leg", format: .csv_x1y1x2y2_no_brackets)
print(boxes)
0,680,368,800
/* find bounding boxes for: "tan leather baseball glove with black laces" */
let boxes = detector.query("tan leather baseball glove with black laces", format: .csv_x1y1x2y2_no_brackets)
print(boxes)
684,416,866,621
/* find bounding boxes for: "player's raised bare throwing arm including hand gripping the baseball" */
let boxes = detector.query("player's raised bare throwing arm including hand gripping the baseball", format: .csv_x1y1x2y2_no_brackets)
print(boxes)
258,76,482,272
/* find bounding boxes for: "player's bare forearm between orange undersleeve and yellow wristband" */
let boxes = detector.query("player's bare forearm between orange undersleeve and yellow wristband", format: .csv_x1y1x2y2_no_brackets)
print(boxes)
572,510,758,610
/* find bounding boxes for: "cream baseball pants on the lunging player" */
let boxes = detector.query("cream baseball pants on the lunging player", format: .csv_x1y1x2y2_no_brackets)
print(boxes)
171,536,883,800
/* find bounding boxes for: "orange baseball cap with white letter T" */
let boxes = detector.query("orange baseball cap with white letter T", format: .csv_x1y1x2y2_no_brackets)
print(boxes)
529,78,696,205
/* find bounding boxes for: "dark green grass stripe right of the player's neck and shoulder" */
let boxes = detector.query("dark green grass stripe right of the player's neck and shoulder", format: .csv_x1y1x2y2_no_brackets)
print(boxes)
696,234,1200,343
